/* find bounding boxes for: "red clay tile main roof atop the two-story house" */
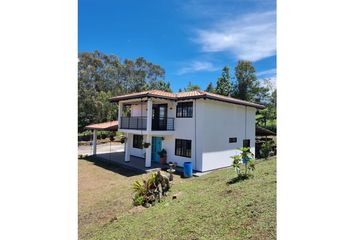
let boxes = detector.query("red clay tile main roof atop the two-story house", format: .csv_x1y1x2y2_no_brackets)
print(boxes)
111,90,264,109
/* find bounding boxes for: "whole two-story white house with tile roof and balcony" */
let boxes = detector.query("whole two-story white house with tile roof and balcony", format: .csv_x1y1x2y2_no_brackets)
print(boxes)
111,90,264,172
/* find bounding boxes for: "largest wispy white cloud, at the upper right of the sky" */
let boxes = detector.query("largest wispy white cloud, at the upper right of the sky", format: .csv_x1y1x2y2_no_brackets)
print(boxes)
194,11,276,61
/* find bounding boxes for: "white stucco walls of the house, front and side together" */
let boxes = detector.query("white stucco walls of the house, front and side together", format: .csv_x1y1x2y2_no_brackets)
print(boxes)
123,99,256,171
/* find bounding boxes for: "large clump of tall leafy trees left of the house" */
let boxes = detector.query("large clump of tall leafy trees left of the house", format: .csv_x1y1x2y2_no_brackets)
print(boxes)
78,51,171,131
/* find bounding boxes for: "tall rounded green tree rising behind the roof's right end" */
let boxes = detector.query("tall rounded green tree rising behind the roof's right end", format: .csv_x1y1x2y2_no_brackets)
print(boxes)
233,60,260,101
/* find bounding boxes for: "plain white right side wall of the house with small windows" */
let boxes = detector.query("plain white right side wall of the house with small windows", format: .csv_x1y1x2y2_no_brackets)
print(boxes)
197,100,256,171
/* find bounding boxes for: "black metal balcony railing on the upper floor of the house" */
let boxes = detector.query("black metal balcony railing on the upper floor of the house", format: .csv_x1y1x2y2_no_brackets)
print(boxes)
119,117,175,131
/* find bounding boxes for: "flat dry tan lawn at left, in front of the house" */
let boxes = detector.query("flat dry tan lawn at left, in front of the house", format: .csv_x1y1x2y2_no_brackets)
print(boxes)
78,160,183,239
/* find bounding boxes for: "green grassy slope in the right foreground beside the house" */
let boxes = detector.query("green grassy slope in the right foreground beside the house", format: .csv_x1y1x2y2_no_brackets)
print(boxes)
88,159,276,239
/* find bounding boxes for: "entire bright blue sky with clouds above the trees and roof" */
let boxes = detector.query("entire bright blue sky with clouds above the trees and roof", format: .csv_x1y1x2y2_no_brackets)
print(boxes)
79,0,276,91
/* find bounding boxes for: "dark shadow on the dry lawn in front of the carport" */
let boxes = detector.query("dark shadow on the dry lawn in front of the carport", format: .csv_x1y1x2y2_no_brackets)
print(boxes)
79,156,144,177
